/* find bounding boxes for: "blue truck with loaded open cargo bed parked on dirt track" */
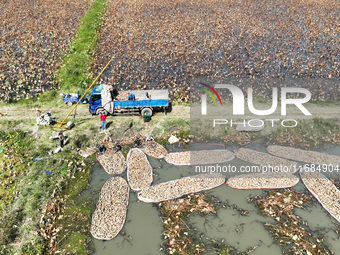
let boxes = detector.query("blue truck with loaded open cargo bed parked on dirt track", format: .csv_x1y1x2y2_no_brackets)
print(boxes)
89,86,171,117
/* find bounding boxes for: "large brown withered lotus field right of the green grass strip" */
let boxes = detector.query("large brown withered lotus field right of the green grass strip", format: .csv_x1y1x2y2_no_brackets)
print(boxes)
97,0,340,100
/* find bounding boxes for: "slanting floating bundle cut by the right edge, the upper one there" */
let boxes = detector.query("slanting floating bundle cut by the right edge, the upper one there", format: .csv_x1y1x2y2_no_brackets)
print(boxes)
267,145,340,167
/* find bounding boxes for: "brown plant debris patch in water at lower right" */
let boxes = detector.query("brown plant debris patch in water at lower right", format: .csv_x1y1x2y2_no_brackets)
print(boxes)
248,189,332,255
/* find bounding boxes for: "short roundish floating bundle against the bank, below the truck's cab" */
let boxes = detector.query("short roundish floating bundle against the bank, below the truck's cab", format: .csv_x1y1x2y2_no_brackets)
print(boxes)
97,149,126,174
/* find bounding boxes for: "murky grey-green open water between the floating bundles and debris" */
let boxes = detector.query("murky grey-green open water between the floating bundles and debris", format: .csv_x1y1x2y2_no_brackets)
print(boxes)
81,146,340,255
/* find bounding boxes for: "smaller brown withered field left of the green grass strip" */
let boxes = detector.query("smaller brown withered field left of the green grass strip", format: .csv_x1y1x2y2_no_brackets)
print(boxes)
0,0,91,101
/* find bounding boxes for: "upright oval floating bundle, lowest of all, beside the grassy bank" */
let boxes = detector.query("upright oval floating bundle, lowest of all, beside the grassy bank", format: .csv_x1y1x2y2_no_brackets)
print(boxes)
90,177,130,240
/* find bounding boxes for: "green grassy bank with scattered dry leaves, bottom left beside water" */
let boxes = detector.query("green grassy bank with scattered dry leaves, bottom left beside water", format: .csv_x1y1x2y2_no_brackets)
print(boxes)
0,131,92,254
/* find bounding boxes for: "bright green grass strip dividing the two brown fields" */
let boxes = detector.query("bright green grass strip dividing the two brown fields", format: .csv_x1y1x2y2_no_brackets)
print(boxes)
58,0,106,91
